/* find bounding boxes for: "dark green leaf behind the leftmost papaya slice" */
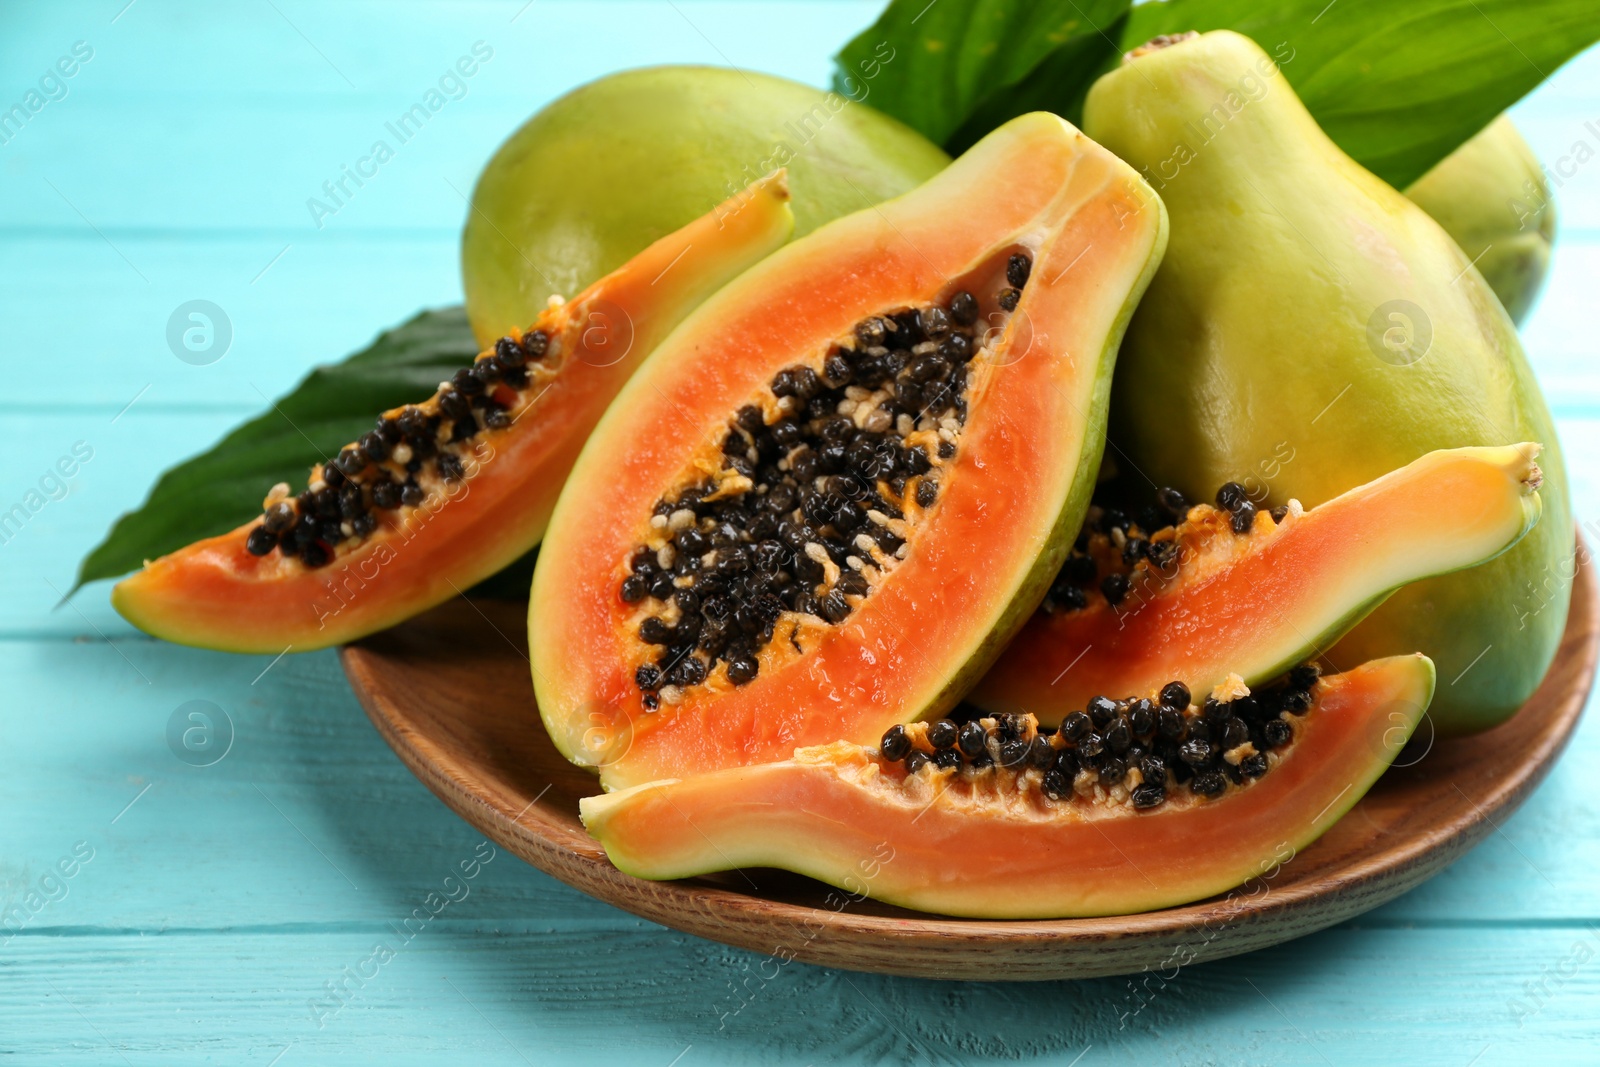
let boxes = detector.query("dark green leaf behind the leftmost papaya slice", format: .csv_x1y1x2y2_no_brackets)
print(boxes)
69,307,473,595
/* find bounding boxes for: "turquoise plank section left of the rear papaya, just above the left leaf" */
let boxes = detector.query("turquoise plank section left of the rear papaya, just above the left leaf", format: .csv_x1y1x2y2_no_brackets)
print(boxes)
0,234,461,416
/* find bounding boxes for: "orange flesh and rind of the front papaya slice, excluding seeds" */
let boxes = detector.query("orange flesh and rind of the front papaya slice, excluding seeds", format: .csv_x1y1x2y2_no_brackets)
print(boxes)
581,656,1434,918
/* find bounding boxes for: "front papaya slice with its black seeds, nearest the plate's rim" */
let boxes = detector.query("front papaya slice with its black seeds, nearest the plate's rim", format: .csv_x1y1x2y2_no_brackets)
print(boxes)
581,656,1434,918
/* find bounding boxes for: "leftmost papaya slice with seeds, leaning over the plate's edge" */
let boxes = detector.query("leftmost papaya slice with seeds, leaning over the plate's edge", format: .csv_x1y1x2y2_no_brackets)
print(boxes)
112,171,794,653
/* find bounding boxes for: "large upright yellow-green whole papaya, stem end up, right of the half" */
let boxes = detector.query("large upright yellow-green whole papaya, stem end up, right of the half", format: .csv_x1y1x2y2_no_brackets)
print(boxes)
1083,30,1573,734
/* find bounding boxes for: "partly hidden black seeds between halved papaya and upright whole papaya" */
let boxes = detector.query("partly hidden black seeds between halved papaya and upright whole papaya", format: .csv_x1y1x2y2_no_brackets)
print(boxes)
1040,482,1288,613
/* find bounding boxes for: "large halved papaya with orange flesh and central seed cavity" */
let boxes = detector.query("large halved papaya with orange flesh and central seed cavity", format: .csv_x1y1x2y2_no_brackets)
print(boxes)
528,114,1166,787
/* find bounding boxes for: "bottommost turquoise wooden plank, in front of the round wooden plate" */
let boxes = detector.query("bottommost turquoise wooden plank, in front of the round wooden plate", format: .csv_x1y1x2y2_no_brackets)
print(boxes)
0,927,1600,1067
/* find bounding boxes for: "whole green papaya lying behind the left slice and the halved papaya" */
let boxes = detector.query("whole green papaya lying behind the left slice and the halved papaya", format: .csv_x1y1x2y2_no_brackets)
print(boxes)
461,67,950,344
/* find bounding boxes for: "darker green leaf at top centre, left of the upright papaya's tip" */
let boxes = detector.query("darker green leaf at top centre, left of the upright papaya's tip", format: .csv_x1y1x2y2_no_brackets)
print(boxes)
834,0,1130,150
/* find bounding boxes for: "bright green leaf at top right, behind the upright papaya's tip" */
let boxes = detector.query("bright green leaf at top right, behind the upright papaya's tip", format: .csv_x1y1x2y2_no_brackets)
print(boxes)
1122,0,1600,189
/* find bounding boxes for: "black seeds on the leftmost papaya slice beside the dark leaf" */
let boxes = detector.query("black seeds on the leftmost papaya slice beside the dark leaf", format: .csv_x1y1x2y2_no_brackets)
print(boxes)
245,330,550,566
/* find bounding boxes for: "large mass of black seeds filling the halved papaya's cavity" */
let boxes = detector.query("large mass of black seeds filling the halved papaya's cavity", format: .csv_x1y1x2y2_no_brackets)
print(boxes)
621,254,1030,709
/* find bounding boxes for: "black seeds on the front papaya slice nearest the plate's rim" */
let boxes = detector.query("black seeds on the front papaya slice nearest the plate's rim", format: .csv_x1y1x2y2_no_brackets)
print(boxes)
878,664,1320,808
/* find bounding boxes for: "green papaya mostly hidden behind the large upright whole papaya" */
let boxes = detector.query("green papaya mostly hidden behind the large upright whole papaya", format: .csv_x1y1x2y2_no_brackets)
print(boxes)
1405,115,1555,323
